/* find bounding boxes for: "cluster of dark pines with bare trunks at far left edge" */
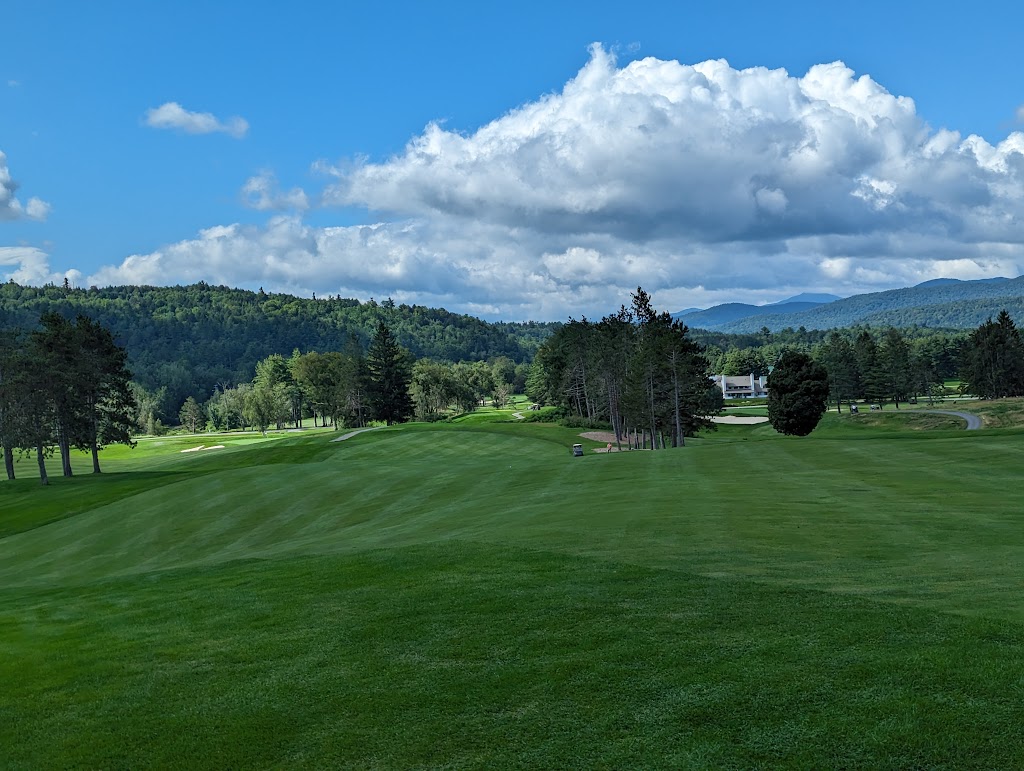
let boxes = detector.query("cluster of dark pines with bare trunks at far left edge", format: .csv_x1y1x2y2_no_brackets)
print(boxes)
0,313,135,484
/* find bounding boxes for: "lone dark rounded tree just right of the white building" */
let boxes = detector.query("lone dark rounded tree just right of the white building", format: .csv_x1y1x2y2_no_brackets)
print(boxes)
768,351,828,436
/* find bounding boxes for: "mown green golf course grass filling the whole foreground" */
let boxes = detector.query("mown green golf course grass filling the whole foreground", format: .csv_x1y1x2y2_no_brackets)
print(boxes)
0,402,1024,769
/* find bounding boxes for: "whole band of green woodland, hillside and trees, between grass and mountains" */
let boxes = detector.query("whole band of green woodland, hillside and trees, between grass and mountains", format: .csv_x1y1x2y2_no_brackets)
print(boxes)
0,284,1024,466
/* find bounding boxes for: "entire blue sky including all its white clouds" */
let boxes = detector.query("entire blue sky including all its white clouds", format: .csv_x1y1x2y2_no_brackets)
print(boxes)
0,0,1024,319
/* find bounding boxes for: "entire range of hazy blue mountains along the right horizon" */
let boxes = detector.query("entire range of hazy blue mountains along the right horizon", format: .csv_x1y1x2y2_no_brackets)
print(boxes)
674,276,1024,333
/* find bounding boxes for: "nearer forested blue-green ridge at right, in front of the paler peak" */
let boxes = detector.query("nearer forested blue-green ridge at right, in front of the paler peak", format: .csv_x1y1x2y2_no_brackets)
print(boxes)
716,276,1024,332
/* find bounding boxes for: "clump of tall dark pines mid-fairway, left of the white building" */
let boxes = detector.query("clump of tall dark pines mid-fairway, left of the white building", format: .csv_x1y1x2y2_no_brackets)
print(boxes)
526,288,722,448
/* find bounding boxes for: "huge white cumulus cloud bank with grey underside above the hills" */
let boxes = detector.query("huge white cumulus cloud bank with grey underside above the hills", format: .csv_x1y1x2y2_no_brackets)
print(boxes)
86,46,1024,318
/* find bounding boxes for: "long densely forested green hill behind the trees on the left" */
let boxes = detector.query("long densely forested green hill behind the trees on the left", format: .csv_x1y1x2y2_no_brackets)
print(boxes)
0,283,560,403
